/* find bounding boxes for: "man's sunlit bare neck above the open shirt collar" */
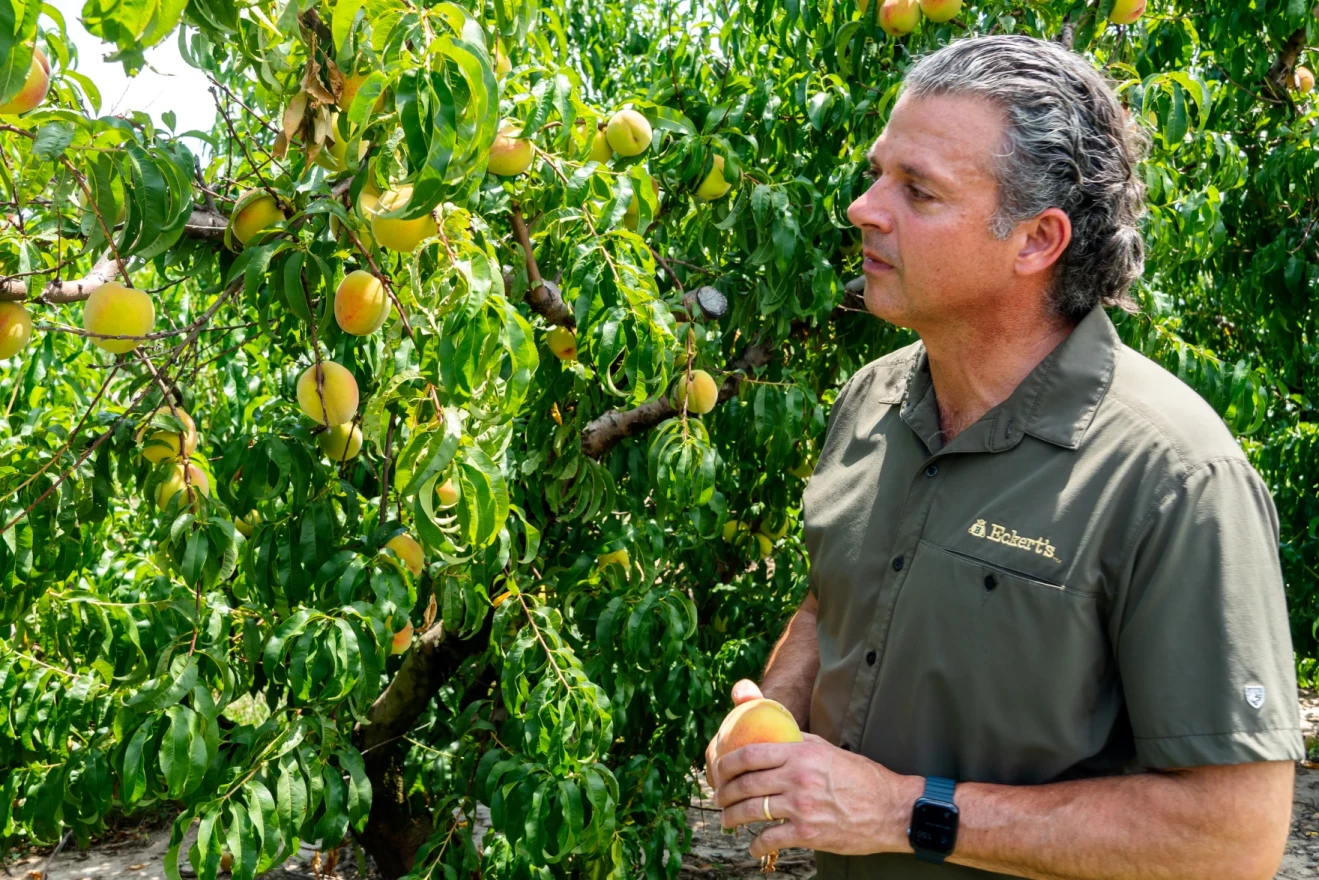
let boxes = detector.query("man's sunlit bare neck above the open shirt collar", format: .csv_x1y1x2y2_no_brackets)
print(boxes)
921,314,1075,443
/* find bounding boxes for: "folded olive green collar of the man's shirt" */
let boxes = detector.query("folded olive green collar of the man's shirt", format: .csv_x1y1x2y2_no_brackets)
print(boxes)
902,306,1121,451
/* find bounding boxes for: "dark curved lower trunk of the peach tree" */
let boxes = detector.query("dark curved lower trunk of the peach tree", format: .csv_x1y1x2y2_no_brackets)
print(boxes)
353,615,493,880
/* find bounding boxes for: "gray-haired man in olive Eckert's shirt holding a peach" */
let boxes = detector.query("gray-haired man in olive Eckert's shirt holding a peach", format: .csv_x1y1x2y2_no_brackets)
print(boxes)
707,36,1303,880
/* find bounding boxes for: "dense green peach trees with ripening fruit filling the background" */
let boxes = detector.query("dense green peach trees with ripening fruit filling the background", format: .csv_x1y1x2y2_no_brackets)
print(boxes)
0,0,1319,880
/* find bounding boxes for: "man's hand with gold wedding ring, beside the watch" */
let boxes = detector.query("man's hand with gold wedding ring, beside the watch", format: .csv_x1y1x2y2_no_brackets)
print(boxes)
715,734,923,859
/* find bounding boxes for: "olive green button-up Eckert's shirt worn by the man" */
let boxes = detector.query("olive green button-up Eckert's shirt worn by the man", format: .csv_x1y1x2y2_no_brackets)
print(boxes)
805,309,1304,880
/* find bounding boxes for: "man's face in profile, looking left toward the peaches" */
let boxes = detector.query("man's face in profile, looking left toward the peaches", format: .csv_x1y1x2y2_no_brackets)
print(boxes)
847,95,1022,331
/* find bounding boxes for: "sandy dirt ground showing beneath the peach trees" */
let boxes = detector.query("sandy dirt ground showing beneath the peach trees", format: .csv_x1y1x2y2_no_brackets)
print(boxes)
0,690,1319,880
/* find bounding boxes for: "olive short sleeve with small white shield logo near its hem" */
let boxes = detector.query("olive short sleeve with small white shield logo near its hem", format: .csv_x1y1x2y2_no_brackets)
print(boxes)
1111,458,1304,769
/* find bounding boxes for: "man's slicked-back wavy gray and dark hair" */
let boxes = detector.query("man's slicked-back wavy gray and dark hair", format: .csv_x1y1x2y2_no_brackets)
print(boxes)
902,34,1149,321
